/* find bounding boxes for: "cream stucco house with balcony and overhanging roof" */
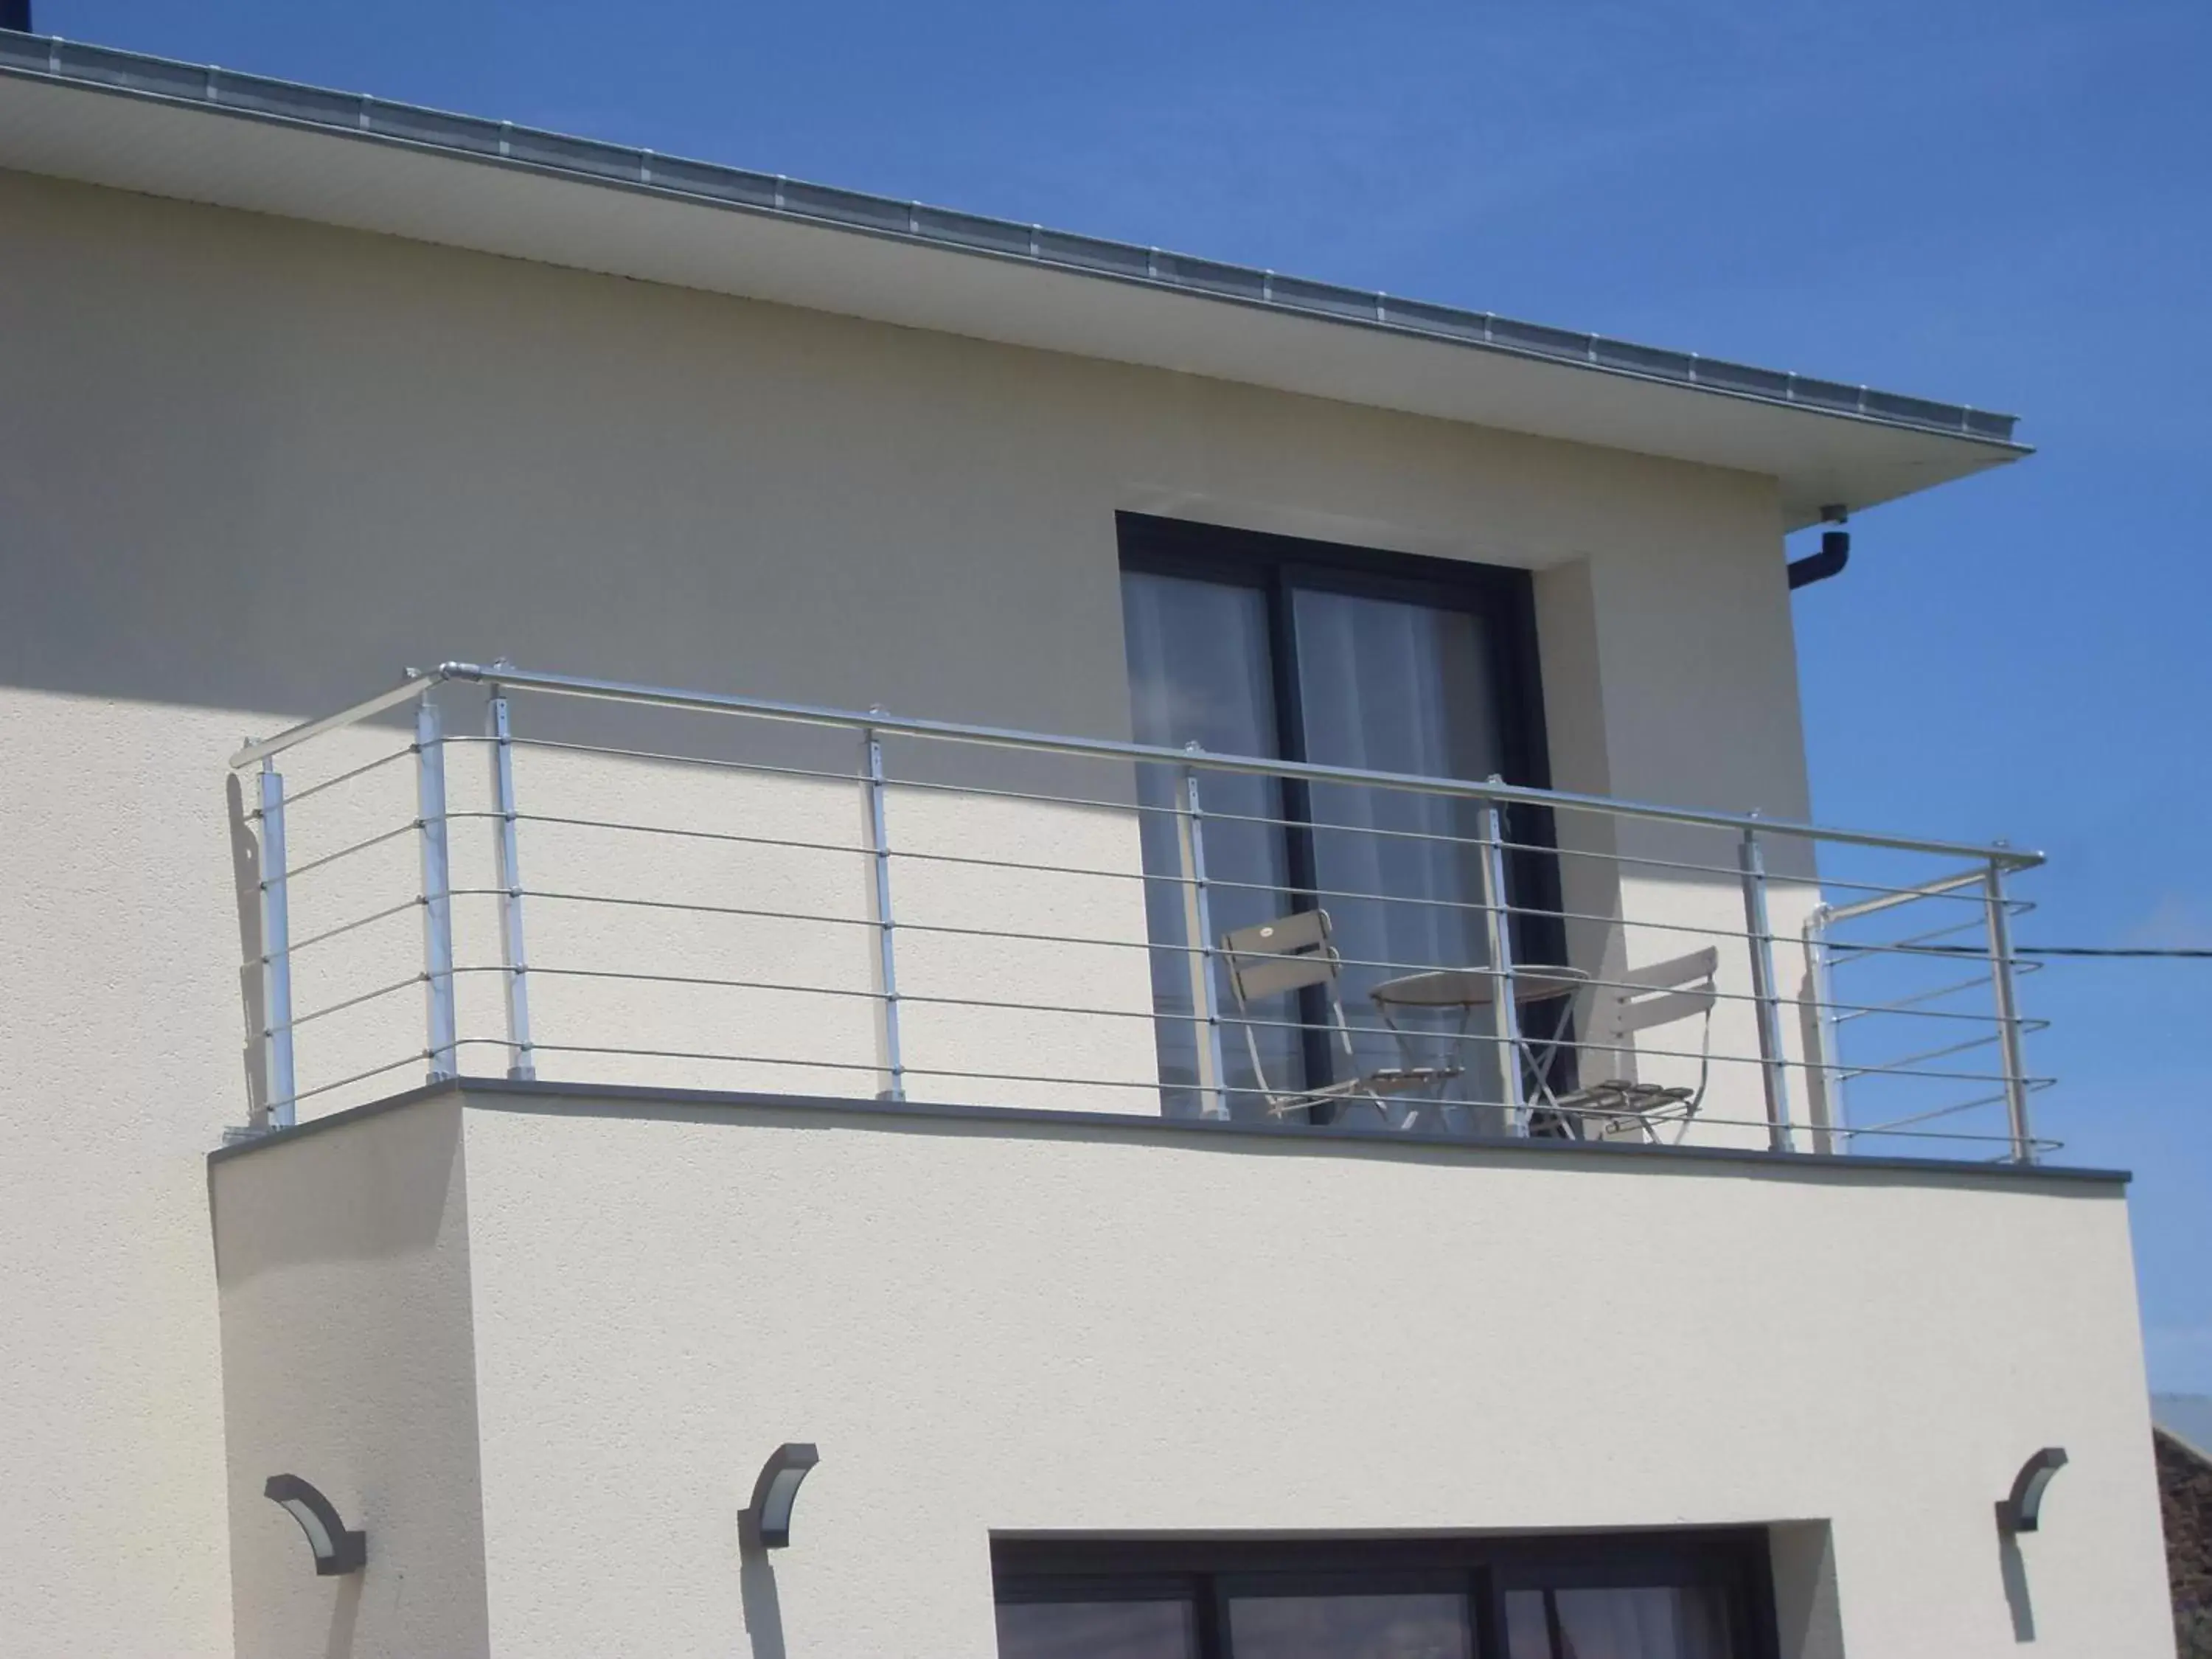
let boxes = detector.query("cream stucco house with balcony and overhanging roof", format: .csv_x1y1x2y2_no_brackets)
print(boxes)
0,33,2172,1659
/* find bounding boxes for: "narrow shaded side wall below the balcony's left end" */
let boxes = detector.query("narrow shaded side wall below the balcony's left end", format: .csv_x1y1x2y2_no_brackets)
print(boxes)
210,1099,489,1659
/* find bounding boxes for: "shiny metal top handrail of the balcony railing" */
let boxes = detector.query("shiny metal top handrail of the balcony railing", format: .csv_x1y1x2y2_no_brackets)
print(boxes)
230,661,2044,869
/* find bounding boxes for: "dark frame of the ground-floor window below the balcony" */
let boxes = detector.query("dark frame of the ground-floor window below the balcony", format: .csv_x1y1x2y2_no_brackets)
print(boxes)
991,1526,1781,1659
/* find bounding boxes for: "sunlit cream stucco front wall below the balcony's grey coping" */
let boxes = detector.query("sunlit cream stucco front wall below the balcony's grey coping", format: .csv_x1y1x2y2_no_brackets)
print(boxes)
217,1097,2172,1659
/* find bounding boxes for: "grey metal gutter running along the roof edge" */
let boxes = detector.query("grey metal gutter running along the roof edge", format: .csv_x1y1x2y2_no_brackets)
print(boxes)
0,31,2020,449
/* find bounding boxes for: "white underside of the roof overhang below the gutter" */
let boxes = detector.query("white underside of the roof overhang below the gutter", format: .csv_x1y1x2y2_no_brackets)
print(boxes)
0,46,2028,526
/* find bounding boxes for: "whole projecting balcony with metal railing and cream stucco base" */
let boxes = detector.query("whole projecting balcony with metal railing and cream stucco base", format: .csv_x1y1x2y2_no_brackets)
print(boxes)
210,664,2161,1659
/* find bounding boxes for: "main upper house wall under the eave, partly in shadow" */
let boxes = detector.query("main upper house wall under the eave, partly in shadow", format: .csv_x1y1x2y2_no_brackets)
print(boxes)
0,153,1920,1655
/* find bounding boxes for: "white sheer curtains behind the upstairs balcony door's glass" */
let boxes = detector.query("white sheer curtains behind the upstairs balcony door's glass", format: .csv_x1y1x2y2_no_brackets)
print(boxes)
1121,571,1502,1130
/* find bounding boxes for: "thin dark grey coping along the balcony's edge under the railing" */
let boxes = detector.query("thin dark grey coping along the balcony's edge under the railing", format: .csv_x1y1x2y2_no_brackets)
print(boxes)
208,1077,2135,1188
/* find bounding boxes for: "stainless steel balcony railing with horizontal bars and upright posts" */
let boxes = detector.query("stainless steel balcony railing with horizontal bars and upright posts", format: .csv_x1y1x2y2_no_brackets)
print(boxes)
230,664,2051,1161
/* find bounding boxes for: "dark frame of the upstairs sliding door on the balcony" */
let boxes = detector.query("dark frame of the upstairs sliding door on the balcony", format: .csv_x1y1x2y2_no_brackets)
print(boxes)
1115,513,1575,1121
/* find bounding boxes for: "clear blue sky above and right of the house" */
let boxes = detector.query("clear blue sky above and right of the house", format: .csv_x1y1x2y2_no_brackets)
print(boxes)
35,0,2212,1391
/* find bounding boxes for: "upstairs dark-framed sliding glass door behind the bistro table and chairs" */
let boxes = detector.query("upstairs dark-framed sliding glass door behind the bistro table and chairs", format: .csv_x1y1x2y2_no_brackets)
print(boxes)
1121,515,1548,1130
